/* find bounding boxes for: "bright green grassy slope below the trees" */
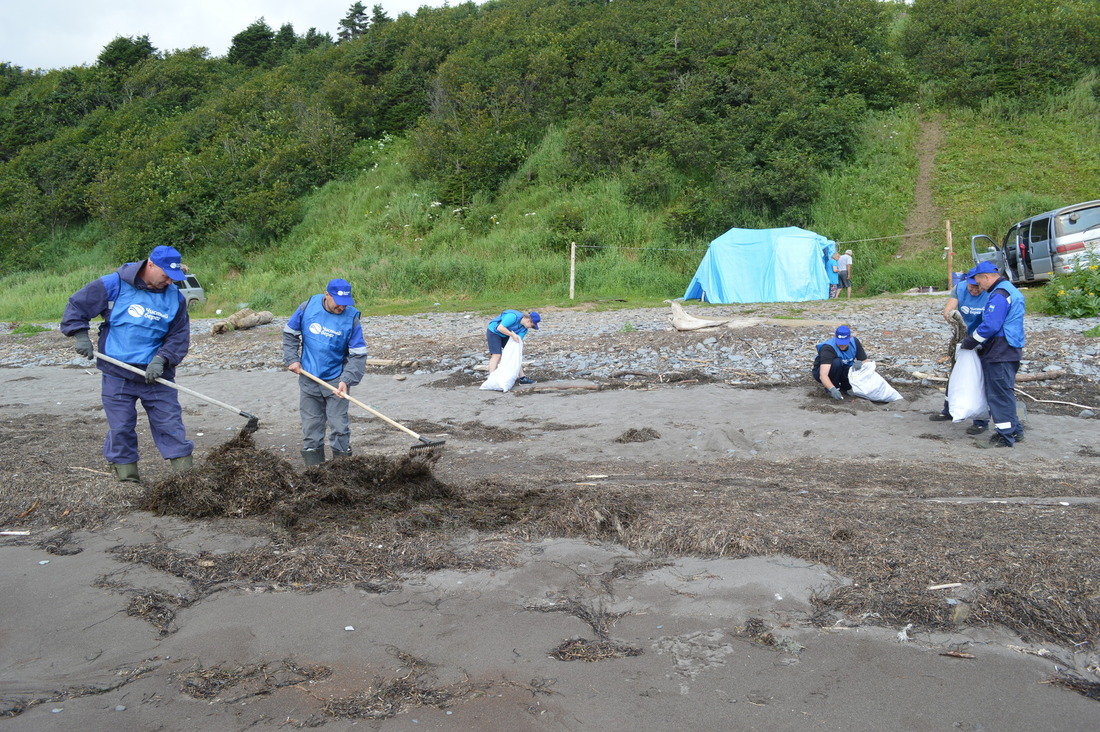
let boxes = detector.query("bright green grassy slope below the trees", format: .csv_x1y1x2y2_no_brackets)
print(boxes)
0,79,1100,321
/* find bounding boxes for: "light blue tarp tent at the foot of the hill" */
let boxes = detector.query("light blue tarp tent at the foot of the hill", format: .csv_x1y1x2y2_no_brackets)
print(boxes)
684,227,836,303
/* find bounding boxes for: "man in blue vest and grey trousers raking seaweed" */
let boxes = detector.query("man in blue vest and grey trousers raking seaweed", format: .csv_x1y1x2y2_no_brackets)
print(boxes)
283,278,366,467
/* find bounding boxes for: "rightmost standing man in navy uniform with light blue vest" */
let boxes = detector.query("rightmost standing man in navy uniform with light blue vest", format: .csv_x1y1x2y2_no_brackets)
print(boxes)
960,262,1026,447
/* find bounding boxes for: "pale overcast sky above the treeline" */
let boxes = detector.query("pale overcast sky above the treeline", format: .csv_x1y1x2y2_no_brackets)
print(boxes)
0,0,458,69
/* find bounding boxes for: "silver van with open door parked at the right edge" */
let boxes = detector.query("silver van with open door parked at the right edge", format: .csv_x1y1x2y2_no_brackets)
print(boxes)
970,200,1100,284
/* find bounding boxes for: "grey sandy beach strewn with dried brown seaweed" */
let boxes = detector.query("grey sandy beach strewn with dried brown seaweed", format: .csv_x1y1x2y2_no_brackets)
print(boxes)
0,299,1100,731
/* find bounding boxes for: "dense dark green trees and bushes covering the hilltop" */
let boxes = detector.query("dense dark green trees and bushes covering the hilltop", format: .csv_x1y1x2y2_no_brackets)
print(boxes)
0,0,1100,273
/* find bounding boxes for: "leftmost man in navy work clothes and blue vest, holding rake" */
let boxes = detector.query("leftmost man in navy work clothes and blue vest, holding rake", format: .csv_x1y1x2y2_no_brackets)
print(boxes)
62,247,195,482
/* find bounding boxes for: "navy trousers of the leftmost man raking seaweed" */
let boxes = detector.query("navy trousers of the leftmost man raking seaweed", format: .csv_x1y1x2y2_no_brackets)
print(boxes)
102,373,195,463
